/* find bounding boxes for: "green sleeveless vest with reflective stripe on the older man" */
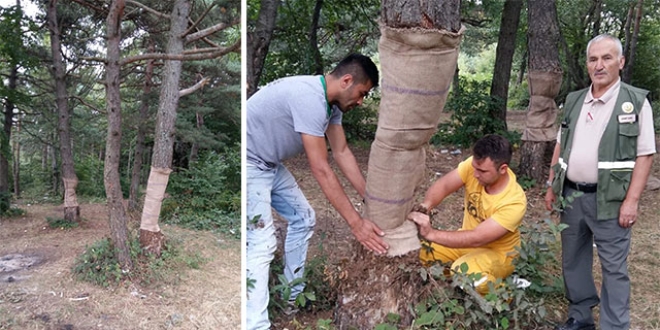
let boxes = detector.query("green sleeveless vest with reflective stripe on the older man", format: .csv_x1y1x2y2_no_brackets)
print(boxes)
552,82,648,220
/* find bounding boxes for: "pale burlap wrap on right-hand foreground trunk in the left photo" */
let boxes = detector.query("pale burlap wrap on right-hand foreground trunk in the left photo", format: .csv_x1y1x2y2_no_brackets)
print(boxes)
140,167,172,232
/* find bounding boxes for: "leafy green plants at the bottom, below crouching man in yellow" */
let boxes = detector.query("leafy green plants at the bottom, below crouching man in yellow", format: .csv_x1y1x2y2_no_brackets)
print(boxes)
412,215,563,329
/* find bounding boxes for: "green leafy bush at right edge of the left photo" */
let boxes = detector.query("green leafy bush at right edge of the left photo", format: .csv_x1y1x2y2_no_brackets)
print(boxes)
161,146,241,238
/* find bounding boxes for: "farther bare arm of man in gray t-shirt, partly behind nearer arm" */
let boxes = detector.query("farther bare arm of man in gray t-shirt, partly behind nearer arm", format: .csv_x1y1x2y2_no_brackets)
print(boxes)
325,124,367,198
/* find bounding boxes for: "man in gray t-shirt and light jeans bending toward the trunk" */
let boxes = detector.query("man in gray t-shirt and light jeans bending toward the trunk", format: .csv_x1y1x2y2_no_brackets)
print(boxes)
246,54,388,330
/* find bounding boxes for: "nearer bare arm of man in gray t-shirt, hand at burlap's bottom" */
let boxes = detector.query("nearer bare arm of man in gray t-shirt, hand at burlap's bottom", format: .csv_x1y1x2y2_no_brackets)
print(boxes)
301,134,388,253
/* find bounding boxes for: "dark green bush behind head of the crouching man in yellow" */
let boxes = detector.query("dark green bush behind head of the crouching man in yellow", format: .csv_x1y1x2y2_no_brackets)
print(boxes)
431,79,520,148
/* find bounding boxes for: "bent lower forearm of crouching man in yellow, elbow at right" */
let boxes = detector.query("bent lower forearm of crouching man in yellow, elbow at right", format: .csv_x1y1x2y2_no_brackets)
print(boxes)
408,212,509,248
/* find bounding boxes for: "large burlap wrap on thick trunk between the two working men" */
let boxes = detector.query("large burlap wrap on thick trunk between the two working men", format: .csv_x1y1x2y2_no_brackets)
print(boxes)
364,24,464,256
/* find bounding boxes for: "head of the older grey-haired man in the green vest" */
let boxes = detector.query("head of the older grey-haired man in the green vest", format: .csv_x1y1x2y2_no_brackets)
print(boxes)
587,39,625,89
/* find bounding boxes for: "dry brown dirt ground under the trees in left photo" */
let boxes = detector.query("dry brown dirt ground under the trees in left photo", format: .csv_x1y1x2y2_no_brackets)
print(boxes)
0,204,241,330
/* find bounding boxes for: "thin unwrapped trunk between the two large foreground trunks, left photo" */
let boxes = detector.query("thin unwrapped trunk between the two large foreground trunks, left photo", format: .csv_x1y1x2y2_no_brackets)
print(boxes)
128,41,154,211
